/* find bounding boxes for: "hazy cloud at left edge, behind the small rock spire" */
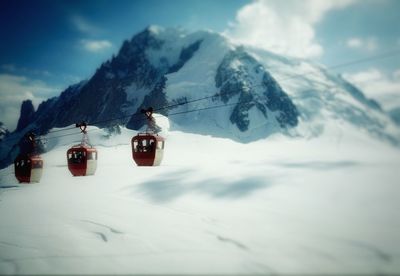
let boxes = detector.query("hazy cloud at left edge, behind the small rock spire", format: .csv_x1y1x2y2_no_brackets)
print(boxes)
0,74,60,130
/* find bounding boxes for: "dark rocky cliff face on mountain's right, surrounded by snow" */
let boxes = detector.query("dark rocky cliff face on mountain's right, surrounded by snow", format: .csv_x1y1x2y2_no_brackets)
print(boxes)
215,48,299,132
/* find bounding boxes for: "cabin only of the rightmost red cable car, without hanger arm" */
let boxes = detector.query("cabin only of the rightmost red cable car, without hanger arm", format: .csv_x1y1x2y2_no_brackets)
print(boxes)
131,133,165,166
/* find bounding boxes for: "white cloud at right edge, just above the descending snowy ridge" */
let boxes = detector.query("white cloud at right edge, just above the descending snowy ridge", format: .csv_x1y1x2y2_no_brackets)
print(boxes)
344,68,400,110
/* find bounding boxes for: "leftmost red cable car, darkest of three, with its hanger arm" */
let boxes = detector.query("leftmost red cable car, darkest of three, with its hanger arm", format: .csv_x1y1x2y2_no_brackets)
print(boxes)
14,133,43,183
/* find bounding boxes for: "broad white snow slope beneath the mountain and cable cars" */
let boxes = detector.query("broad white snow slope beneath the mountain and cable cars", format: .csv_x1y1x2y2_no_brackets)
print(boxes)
0,118,400,274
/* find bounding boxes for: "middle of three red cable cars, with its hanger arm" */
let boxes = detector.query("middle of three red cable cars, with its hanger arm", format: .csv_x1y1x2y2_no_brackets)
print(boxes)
67,123,97,176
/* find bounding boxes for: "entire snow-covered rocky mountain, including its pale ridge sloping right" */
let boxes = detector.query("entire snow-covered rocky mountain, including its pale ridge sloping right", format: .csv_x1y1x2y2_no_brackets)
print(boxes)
0,26,400,168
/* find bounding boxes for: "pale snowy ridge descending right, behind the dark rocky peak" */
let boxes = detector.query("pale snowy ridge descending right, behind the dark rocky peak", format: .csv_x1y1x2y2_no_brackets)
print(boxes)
247,48,400,142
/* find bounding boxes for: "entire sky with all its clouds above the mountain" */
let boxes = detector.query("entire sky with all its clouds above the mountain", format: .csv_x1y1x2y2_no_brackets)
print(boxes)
0,0,400,129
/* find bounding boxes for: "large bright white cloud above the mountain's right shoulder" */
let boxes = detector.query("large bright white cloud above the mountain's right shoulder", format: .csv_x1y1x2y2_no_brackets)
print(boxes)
224,0,356,58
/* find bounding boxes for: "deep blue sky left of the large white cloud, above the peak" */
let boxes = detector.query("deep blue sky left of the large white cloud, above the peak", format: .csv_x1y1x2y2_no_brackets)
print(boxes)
0,0,246,85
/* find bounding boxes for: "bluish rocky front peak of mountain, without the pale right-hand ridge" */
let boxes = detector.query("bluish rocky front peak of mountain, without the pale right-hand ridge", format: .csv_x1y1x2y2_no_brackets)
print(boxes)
10,26,299,138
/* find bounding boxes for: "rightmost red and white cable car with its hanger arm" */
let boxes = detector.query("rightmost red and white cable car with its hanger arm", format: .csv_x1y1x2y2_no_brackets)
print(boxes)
131,107,165,166
